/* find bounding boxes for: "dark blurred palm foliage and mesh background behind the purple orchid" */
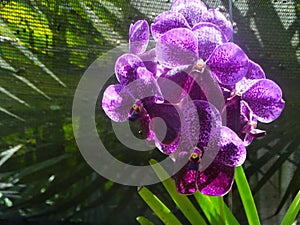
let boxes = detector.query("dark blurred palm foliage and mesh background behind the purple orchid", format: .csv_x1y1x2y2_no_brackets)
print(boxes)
0,0,300,224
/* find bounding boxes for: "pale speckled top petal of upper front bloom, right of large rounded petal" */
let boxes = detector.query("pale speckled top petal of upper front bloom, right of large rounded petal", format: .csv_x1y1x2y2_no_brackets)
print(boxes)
192,22,226,60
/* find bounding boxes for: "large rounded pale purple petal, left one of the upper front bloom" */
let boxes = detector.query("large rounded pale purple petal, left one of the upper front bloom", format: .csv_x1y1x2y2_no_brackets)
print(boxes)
156,28,198,68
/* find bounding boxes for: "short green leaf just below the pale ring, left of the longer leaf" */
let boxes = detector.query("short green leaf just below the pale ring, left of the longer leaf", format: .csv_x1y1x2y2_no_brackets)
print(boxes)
138,187,181,225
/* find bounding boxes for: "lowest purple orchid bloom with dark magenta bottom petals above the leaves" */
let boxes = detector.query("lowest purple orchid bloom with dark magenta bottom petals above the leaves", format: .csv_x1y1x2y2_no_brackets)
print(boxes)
174,100,246,196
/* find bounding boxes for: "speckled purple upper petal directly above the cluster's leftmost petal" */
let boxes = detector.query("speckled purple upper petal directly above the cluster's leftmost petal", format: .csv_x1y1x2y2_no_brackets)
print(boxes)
115,54,145,85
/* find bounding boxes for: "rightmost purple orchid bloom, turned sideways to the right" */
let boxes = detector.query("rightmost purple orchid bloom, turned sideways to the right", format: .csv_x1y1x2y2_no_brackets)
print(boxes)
224,61,285,146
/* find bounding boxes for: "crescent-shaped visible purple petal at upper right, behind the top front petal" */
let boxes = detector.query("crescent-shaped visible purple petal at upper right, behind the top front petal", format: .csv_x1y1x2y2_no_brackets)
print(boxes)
202,9,233,41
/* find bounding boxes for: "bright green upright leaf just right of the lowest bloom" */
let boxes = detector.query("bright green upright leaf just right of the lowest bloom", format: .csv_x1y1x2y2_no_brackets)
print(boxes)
234,166,260,225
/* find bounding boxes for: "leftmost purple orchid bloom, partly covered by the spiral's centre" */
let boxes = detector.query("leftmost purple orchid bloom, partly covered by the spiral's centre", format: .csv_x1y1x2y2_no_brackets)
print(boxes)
102,49,186,154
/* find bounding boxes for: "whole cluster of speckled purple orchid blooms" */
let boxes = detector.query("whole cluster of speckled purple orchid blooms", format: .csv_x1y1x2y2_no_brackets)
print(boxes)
102,0,285,196
